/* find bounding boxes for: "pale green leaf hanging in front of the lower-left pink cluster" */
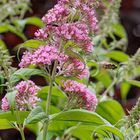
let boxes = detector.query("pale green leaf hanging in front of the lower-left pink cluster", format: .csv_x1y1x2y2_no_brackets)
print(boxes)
6,90,17,112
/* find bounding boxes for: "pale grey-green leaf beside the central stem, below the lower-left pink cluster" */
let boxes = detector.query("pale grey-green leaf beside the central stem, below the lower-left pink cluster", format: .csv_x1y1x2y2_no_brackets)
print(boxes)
25,106,47,125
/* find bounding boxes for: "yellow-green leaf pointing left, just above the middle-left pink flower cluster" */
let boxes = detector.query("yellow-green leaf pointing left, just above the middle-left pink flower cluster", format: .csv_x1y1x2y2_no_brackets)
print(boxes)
16,39,44,49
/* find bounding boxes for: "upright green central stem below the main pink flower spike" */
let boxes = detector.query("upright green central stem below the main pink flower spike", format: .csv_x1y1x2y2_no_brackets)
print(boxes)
43,61,58,140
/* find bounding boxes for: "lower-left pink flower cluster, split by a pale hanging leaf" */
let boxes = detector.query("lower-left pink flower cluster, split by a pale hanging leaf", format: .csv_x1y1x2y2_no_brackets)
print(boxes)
1,80,40,111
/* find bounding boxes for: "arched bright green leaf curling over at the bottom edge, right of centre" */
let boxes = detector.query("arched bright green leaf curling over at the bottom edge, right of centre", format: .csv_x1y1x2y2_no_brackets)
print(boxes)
94,125,124,140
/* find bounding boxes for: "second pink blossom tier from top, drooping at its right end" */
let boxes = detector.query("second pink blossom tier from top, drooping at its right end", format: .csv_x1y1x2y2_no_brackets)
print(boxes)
35,22,93,53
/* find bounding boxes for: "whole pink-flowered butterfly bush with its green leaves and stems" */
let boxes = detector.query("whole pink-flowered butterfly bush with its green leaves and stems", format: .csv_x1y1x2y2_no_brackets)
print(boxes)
0,0,140,140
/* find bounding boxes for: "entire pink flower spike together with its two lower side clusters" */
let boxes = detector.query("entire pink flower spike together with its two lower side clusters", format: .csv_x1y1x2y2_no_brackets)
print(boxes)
2,0,98,111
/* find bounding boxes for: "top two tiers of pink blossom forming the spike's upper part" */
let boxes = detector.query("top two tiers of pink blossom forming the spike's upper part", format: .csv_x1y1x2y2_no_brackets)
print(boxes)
35,0,98,53
